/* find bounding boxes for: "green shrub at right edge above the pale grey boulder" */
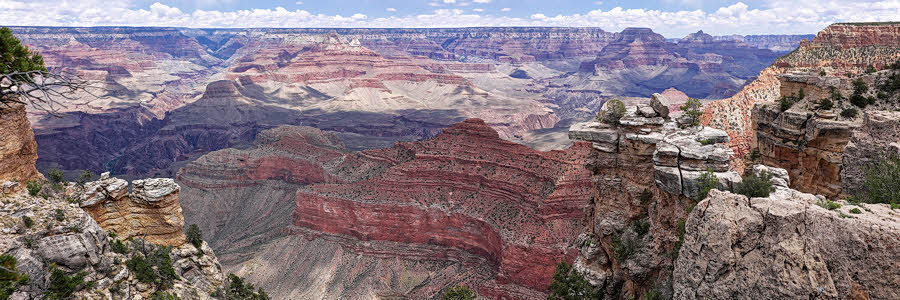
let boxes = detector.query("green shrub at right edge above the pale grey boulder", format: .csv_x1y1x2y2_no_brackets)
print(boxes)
854,153,900,204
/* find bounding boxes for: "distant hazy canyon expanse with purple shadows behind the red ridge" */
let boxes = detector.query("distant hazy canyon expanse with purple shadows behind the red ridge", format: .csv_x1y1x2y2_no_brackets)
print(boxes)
12,27,805,178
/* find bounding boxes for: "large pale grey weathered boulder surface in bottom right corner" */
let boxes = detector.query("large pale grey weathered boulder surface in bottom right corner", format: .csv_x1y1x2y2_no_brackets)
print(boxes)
673,189,900,299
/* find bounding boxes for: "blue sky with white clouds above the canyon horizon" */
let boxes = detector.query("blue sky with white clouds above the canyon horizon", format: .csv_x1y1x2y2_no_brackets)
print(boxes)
0,0,900,37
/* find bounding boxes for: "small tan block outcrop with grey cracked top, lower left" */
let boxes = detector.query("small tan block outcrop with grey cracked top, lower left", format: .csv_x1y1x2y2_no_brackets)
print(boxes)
79,173,185,246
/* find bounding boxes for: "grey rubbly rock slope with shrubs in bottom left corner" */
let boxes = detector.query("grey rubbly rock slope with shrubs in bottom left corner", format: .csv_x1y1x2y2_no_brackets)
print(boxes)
0,184,225,299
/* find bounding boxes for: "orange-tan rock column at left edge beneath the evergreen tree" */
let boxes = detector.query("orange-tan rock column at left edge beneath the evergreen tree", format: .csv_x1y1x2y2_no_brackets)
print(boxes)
0,103,42,185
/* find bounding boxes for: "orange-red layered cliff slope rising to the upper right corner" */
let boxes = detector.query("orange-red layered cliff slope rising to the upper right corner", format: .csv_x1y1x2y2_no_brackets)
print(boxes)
703,24,900,175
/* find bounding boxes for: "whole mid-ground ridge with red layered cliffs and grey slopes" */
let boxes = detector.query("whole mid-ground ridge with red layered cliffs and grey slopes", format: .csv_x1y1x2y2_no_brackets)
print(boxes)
178,119,590,298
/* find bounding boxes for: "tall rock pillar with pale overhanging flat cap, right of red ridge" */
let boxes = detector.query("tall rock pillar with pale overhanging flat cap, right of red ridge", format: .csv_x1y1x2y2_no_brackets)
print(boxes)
569,101,740,298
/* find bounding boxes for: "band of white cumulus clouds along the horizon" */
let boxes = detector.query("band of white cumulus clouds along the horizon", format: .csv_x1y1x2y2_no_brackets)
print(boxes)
0,0,900,37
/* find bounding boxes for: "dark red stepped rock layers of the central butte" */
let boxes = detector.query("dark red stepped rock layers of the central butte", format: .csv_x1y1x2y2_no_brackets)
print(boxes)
293,119,590,291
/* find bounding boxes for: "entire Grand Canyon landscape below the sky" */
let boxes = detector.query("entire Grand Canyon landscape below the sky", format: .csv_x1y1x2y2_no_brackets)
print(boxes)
0,1,900,299
